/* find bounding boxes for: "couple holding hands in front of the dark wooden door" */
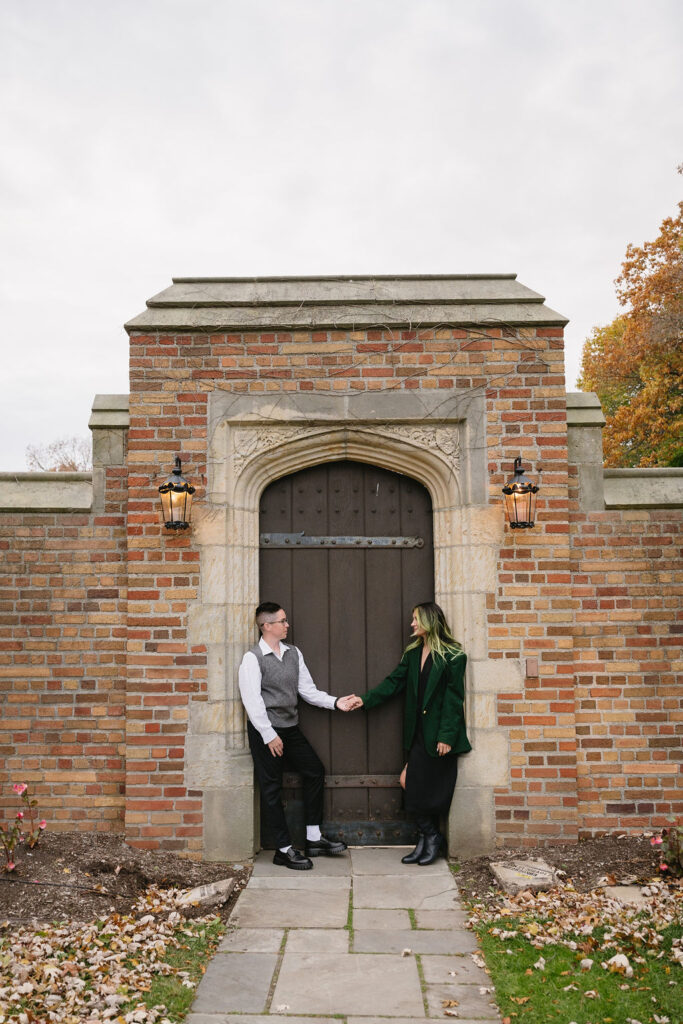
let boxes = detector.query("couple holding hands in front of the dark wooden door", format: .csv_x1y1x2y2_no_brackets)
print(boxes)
239,601,471,870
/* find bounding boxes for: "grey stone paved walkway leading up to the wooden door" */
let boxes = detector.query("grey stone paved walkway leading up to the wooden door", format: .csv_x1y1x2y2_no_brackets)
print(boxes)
186,847,501,1024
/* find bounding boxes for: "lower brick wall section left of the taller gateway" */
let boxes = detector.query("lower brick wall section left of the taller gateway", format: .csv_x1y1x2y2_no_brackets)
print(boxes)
0,468,126,831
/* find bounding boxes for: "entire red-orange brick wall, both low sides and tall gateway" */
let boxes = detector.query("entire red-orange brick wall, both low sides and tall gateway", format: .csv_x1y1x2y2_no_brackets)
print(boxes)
0,329,682,857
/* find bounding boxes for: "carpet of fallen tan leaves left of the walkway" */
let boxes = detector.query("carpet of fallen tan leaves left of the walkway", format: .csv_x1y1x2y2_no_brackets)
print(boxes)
0,887,216,1024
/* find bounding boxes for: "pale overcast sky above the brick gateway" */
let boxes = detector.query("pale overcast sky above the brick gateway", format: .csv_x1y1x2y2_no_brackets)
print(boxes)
0,0,683,470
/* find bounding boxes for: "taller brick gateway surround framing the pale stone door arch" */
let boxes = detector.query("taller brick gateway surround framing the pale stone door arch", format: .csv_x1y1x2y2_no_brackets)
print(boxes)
126,329,577,855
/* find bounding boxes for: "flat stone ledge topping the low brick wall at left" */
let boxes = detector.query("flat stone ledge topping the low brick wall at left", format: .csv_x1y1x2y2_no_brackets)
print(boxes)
0,473,92,512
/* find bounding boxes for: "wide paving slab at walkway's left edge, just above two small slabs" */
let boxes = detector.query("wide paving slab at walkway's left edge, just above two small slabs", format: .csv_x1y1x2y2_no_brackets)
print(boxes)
230,886,348,928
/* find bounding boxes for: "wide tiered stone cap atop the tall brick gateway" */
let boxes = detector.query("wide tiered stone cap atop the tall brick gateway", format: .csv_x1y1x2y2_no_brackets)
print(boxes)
126,273,567,333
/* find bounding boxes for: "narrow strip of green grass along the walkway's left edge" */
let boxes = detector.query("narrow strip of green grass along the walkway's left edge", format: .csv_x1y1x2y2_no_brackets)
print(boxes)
120,918,225,1024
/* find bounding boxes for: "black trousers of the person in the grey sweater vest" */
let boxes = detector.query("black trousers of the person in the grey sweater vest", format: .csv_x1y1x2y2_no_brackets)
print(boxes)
247,722,325,849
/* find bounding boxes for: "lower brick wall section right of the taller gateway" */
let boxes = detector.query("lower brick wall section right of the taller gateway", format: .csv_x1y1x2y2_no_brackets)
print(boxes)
571,499,683,836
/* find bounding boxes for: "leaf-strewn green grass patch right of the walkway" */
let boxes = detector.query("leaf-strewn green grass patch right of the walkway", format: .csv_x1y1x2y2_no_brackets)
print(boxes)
476,918,683,1024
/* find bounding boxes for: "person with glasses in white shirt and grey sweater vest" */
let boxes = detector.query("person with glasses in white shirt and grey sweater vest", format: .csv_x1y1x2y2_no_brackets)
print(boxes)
239,601,352,871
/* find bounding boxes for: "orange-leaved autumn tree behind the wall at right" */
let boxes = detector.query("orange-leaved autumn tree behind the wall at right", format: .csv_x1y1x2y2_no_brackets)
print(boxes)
579,196,683,466
